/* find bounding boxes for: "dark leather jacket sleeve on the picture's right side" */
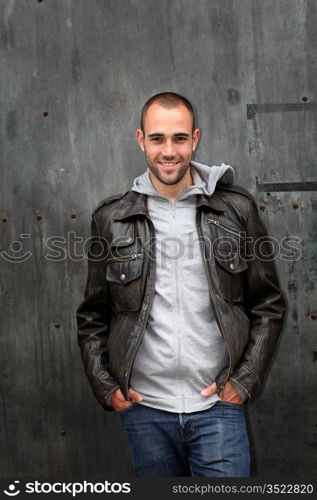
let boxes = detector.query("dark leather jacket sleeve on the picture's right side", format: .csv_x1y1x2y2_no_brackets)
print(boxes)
230,200,286,400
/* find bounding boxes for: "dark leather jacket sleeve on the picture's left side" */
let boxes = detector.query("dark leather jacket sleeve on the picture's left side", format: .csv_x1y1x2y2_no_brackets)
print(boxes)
76,214,119,410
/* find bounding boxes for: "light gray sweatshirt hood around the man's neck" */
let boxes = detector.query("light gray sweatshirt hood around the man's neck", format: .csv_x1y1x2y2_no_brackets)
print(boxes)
131,161,235,199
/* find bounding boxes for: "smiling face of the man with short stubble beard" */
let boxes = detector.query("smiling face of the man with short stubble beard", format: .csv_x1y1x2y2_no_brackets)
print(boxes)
137,103,200,185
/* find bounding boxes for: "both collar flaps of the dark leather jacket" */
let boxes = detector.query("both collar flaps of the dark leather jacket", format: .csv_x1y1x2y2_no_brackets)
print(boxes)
113,191,225,220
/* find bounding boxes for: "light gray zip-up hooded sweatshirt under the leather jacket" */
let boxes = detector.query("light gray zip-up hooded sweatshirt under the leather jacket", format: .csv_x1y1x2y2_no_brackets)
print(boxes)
130,161,234,413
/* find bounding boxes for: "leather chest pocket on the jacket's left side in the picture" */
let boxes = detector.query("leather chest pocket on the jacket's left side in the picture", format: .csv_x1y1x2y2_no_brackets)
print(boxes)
106,238,143,311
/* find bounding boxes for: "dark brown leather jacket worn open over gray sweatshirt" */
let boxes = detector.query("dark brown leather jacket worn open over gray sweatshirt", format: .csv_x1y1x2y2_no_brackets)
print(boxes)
77,183,285,409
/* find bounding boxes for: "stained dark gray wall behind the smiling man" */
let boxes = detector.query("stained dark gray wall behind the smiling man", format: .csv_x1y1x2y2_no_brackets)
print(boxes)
0,0,317,479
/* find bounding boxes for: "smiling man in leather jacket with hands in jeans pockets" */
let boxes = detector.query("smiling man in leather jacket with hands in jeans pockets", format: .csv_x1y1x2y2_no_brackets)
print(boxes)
77,93,285,477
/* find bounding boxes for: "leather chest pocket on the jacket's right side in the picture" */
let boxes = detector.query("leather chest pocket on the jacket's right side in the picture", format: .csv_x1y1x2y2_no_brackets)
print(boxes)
207,218,248,302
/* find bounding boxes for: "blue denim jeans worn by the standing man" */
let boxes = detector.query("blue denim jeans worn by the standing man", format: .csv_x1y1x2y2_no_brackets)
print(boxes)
119,401,250,477
